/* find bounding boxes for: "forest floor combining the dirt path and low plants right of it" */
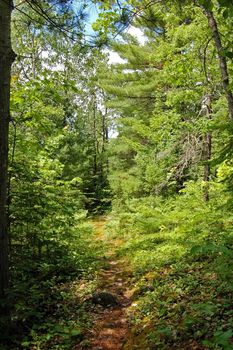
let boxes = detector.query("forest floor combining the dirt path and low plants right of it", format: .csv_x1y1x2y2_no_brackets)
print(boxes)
72,213,233,350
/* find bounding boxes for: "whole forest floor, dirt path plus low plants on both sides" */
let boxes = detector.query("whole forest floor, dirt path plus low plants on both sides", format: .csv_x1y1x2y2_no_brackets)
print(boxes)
6,214,233,350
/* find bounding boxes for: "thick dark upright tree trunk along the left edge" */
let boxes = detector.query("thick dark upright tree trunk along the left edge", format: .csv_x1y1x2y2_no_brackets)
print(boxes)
0,0,15,304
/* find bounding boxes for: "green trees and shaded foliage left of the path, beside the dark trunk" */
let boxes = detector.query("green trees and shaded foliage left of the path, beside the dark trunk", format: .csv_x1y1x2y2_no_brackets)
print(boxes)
0,7,110,350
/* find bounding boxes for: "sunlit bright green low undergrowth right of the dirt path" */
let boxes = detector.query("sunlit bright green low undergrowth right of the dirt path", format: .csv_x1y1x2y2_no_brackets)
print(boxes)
108,183,233,350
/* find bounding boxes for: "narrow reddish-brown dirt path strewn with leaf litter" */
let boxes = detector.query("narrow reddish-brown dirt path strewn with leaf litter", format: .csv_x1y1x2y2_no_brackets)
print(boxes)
75,217,132,350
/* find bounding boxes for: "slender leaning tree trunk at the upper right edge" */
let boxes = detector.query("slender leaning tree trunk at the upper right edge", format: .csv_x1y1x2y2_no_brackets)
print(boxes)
204,8,233,120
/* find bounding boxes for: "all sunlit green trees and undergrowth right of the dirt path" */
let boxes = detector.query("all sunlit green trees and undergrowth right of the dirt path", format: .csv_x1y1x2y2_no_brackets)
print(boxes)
102,1,233,349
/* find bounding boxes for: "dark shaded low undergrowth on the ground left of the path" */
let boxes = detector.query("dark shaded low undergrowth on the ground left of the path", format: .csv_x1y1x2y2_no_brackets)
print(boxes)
0,220,102,350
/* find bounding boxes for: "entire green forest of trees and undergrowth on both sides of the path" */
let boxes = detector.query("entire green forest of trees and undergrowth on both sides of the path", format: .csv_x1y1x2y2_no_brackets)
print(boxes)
0,0,233,350
